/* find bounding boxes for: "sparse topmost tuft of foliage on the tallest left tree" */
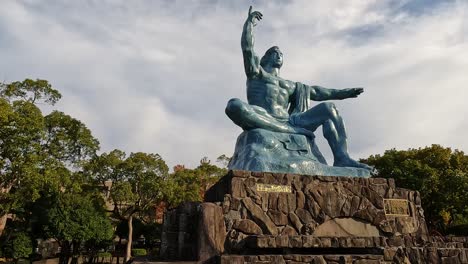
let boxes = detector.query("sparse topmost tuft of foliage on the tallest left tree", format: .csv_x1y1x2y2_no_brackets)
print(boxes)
0,79,62,105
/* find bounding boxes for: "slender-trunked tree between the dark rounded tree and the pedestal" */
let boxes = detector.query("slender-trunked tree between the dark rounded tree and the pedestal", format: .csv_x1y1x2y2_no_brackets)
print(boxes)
85,150,169,261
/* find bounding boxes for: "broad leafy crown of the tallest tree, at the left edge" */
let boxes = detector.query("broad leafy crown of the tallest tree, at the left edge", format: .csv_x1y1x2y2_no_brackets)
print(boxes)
0,79,99,216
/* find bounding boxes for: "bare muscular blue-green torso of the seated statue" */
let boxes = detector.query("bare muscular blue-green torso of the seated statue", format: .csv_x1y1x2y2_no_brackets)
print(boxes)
247,70,294,119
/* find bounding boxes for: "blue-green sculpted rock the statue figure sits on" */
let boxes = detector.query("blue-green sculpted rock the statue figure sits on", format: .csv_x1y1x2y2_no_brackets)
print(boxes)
228,129,370,177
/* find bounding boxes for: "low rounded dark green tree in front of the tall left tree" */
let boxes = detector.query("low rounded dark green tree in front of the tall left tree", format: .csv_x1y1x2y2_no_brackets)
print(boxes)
31,191,113,264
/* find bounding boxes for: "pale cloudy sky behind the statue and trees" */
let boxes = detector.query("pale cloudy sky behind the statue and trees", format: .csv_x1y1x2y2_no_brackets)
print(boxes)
0,0,468,167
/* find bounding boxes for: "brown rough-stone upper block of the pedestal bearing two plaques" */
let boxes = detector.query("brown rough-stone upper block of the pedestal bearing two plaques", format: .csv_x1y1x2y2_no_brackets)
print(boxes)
205,171,427,247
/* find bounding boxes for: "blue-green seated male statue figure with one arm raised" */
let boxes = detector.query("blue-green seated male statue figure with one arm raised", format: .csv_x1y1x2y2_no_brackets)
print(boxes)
226,7,372,173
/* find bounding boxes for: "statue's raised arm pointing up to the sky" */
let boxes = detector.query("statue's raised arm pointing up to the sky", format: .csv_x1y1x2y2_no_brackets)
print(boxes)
241,6,263,78
